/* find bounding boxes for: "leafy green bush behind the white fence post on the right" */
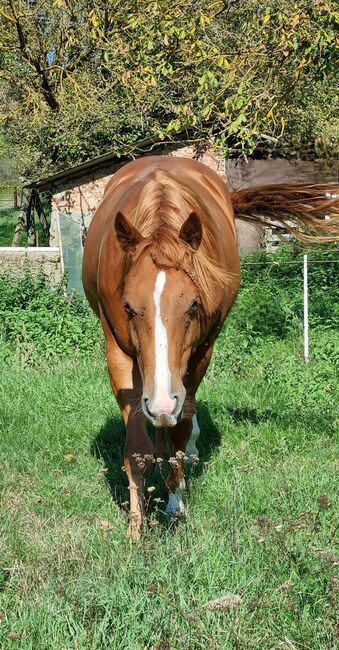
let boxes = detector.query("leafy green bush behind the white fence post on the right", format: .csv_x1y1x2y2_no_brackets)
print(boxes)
238,243,339,338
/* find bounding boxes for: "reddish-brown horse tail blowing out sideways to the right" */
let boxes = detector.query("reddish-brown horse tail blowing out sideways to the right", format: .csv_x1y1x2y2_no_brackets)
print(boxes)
231,183,339,242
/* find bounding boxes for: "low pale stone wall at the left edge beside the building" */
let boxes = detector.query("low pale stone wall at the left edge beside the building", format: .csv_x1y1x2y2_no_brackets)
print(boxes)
0,246,62,284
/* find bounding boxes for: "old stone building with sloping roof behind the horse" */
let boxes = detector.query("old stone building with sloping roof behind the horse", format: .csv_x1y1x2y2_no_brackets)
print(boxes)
28,142,338,292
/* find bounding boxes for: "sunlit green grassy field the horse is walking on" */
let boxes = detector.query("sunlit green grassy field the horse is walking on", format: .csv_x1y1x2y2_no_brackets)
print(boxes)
0,249,339,650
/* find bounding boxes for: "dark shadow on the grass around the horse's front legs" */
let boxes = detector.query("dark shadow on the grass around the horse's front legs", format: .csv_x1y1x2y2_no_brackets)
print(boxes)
91,402,221,512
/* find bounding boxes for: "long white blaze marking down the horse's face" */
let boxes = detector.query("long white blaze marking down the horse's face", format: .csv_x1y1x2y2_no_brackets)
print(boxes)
152,271,175,412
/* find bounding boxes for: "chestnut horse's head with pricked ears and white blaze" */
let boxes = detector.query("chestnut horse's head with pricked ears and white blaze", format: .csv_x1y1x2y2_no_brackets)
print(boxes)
115,212,203,427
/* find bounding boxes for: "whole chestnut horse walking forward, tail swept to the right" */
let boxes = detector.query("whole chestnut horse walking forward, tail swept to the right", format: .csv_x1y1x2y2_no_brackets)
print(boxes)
83,156,339,538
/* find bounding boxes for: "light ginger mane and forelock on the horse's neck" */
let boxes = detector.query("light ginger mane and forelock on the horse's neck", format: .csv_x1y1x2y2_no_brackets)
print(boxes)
122,169,232,316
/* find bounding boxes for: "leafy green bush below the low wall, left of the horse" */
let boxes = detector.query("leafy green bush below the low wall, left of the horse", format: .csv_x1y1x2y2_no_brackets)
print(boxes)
0,271,102,363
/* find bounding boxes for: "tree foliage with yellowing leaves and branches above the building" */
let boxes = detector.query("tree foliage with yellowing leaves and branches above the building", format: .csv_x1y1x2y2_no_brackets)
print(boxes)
0,0,338,176
